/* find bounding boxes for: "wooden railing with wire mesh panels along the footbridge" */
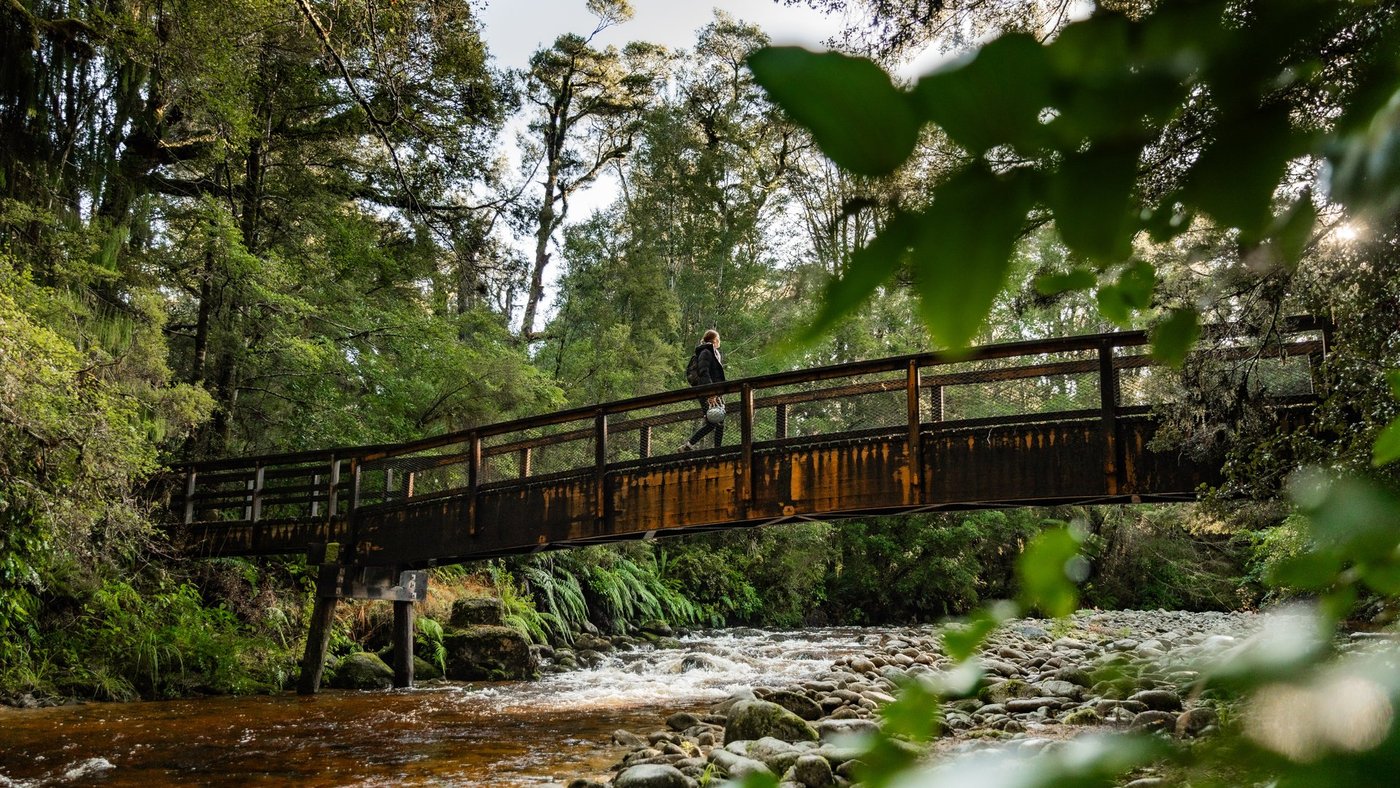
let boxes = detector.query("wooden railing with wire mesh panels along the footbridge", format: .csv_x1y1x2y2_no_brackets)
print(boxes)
163,318,1324,540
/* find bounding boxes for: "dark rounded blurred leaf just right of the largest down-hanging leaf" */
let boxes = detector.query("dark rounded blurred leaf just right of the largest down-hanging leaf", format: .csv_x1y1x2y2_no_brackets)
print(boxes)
1047,146,1141,262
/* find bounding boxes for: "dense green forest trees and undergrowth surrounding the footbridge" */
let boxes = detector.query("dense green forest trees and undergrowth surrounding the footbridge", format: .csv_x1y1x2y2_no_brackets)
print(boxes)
0,7,1400,767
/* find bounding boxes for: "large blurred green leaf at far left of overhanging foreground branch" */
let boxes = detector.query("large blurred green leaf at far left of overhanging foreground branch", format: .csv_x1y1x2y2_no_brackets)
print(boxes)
749,46,920,175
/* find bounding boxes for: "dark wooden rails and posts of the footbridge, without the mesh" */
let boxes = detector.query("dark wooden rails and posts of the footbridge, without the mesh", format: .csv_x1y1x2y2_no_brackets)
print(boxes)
163,316,1326,522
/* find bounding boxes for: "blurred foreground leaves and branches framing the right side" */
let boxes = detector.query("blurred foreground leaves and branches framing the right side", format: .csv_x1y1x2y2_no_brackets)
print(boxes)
746,0,1400,787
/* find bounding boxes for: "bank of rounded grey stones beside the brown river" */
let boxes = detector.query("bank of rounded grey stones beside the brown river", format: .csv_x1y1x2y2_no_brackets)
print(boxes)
568,610,1288,788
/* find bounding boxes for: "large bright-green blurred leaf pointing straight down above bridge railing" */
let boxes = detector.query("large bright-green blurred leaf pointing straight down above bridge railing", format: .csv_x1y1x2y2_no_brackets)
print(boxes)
913,165,1032,349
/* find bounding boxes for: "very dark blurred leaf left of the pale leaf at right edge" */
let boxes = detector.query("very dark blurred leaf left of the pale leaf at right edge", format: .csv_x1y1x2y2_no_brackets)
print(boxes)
1183,106,1306,239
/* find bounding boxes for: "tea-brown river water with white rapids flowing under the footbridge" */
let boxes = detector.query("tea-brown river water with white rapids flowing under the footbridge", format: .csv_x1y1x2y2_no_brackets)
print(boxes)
0,628,882,788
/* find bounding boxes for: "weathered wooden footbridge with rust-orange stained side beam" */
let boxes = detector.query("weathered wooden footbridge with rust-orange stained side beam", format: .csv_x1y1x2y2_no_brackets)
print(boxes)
161,318,1326,691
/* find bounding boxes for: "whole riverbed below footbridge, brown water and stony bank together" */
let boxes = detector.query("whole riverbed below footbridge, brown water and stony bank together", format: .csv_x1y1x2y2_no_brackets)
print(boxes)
0,612,1332,788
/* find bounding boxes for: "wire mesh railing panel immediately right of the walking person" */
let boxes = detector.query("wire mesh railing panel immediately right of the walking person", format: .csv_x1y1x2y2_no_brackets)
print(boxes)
753,370,909,441
